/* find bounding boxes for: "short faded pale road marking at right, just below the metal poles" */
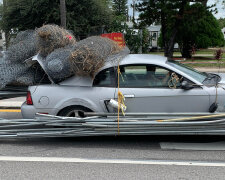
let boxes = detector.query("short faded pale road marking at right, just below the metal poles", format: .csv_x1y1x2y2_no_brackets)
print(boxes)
160,141,225,151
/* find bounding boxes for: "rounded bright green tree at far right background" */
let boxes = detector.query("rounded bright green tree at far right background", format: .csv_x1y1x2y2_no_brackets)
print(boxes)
176,3,224,58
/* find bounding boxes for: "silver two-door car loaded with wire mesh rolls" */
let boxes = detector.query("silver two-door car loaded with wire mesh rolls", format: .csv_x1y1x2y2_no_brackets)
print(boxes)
22,54,225,118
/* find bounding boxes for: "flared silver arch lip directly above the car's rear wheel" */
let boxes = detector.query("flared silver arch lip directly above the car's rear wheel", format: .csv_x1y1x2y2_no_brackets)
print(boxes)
55,98,101,112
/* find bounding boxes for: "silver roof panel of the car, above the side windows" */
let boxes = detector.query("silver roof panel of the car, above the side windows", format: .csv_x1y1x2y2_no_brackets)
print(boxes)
102,54,167,69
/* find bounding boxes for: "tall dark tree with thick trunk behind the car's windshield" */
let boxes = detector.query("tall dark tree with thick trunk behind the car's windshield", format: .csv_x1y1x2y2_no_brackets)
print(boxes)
137,0,214,57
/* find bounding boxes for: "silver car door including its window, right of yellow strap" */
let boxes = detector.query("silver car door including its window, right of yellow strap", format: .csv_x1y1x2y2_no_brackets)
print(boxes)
117,65,210,112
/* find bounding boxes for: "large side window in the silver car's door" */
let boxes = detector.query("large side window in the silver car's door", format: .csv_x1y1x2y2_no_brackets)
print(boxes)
119,65,182,88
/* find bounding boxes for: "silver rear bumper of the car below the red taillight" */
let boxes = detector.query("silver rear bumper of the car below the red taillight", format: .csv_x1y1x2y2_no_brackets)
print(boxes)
21,102,58,119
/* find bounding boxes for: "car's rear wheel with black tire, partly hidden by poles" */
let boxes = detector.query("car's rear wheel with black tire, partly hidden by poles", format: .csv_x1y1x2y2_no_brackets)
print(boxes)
58,106,92,118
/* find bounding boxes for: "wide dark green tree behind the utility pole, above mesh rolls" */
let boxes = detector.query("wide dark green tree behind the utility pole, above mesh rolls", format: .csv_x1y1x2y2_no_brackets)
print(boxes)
0,0,112,39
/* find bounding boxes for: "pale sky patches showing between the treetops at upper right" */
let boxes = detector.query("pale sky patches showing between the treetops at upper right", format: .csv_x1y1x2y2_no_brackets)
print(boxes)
128,0,225,19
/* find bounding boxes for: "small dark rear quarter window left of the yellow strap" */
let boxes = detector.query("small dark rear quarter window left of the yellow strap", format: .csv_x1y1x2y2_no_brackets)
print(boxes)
93,68,115,87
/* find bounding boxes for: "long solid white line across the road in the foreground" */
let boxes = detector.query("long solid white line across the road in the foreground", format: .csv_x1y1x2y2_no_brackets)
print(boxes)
0,156,225,167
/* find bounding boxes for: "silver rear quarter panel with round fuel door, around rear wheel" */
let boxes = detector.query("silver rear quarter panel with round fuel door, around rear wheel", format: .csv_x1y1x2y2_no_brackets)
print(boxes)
29,85,110,112
